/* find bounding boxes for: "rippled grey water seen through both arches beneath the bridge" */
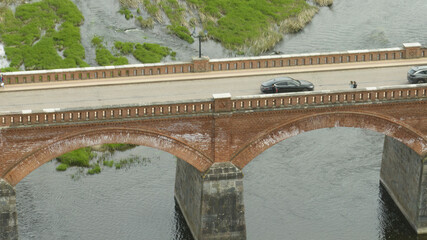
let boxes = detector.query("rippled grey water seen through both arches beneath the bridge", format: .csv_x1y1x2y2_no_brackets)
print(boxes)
16,128,422,240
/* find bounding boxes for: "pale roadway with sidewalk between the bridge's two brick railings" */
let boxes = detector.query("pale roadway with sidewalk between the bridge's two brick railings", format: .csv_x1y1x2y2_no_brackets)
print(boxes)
0,58,427,115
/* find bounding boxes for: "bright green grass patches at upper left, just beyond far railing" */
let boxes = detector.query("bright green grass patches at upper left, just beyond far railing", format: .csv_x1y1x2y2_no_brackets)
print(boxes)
0,0,176,72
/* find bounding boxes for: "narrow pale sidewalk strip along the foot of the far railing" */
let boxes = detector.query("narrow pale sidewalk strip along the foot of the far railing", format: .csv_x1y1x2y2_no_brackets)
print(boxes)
0,58,427,92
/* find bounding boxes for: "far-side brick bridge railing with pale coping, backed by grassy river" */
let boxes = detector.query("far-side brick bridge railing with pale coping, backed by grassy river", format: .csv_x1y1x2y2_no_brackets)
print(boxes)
4,43,427,84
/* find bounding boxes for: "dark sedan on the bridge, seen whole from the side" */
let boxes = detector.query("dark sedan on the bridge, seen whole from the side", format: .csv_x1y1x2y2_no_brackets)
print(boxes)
260,77,314,93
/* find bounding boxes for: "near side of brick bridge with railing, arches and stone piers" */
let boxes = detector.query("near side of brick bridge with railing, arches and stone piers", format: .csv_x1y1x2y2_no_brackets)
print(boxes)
0,84,427,239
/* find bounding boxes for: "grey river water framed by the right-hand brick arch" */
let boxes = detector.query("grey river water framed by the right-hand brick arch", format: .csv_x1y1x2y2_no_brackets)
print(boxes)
243,127,417,239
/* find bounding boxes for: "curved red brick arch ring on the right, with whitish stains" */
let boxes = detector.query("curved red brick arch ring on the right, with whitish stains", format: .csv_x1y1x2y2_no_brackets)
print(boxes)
231,112,427,169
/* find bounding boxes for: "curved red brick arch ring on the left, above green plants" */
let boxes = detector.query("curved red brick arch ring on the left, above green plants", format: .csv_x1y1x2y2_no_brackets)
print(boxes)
2,128,213,186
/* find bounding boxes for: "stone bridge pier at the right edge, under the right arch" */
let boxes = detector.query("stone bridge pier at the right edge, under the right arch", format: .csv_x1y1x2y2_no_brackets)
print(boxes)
380,136,427,234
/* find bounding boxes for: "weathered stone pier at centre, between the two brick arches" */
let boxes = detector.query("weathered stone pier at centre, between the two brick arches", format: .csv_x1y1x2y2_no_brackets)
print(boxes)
175,159,246,240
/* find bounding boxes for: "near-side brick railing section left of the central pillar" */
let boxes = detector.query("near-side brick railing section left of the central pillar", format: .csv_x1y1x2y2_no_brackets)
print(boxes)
0,100,214,127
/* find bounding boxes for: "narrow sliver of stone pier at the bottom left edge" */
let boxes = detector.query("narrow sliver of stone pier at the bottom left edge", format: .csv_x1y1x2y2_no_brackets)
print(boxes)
0,179,18,240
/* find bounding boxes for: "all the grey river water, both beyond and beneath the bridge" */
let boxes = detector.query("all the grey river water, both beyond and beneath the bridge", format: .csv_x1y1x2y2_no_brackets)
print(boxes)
8,0,427,240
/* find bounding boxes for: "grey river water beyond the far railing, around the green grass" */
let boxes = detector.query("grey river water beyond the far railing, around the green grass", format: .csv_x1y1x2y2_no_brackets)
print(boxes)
73,0,427,64
